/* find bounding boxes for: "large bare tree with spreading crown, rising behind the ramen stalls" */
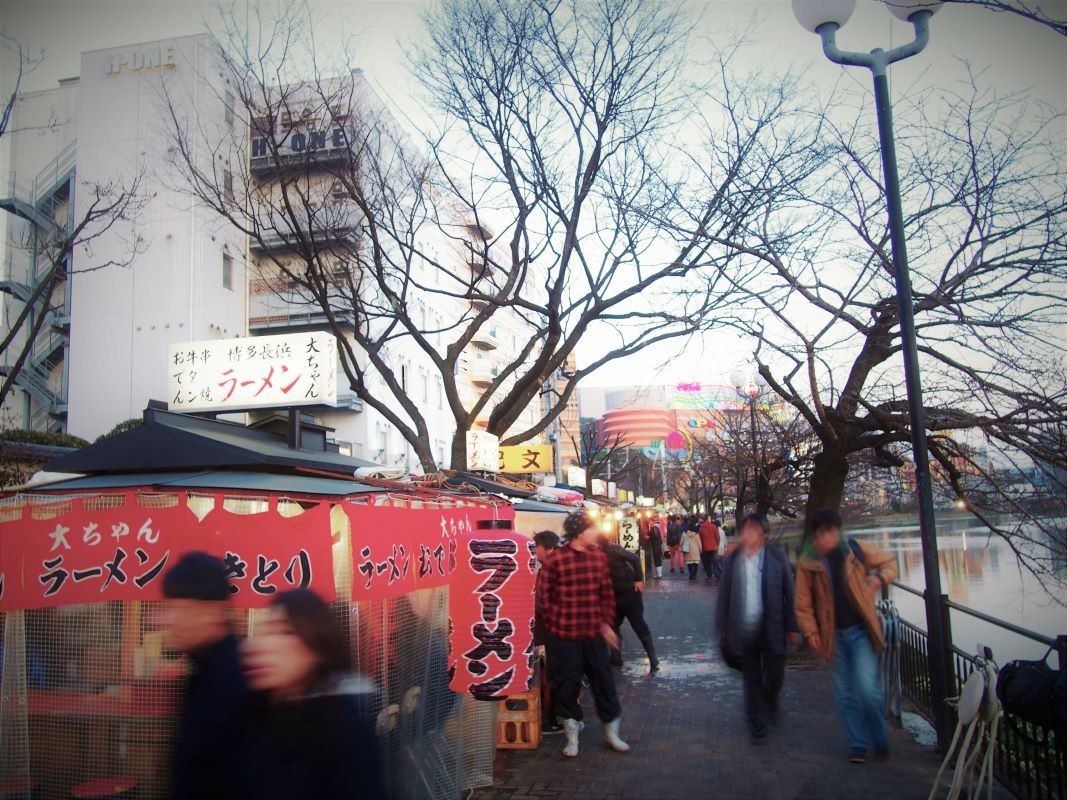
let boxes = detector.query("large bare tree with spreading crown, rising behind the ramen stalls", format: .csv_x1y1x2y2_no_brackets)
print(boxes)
164,0,802,470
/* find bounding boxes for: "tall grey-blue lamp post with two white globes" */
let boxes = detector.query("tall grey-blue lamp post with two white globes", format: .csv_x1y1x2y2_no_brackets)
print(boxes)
793,0,952,750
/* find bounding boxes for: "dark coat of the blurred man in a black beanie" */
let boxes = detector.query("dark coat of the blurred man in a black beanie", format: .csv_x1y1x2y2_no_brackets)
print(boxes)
171,635,251,800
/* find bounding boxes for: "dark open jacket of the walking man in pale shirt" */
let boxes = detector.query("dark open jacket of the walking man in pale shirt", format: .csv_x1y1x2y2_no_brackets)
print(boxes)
715,542,799,656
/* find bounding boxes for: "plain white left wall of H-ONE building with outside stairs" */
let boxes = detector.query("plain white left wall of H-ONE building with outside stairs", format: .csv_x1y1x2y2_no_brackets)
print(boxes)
0,36,245,439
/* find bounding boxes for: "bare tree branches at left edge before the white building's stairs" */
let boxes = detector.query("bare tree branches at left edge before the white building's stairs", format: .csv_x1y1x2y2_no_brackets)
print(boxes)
0,34,144,416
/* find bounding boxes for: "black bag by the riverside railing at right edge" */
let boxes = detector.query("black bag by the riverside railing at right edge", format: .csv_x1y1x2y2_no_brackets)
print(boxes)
997,647,1067,741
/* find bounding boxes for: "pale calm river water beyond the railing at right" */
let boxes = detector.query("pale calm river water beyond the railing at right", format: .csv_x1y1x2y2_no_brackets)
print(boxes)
850,519,1067,667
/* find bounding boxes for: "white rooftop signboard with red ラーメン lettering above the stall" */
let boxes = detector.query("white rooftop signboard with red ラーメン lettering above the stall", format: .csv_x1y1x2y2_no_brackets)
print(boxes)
166,331,337,412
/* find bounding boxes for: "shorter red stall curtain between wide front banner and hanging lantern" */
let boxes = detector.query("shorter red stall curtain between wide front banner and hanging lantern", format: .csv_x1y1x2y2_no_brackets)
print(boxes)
344,503,505,601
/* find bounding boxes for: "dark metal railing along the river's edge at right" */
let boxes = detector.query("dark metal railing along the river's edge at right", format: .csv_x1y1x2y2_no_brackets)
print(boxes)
893,583,1067,800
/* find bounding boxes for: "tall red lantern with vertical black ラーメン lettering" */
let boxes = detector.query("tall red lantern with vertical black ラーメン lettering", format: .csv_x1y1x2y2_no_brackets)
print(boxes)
448,529,537,700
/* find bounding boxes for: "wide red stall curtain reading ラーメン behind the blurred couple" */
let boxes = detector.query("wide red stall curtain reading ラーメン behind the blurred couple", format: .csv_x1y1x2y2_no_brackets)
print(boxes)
0,494,335,611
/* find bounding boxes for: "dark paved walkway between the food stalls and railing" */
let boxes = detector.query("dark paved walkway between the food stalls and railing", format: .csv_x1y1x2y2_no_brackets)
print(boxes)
475,571,939,800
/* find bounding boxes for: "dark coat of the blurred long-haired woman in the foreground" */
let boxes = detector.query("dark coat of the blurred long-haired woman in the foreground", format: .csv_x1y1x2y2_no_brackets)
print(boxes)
241,678,387,800
